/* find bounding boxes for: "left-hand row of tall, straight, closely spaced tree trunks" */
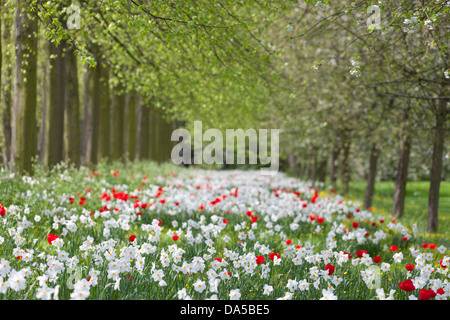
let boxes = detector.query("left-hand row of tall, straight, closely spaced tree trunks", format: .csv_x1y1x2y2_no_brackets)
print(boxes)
0,0,216,173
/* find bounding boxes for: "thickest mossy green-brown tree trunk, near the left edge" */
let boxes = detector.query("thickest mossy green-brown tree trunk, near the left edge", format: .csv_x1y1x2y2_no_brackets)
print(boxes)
11,0,38,174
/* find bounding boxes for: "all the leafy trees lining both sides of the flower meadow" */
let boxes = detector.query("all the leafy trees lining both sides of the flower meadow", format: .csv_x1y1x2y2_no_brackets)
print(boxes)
0,0,450,232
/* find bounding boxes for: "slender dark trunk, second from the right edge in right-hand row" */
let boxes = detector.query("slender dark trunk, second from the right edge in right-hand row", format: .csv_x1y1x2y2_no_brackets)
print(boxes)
392,130,411,218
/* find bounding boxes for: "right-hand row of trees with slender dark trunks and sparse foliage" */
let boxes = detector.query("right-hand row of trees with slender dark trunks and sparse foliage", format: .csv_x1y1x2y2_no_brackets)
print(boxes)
273,1,450,232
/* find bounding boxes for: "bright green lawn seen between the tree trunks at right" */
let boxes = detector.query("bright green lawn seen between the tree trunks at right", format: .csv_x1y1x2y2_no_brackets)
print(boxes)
337,181,450,236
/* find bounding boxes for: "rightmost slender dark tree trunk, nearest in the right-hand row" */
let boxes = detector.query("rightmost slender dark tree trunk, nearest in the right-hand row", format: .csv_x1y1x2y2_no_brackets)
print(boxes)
428,95,447,232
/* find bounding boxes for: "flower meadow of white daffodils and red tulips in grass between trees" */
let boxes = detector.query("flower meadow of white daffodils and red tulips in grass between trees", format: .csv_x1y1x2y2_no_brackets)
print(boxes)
0,162,450,300
